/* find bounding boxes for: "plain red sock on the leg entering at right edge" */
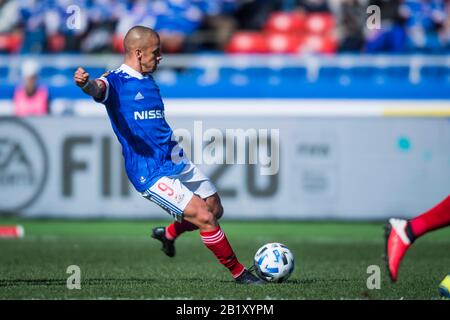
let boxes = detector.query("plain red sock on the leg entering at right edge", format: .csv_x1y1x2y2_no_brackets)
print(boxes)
409,196,450,238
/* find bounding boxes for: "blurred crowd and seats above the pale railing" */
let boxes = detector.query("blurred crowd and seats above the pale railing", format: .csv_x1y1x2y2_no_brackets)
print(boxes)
0,0,450,53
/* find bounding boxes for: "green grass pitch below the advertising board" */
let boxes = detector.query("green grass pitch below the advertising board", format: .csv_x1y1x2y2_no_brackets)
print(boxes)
0,219,450,300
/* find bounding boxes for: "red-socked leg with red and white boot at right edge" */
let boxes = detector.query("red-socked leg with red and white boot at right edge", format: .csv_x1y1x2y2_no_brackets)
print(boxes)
385,196,450,281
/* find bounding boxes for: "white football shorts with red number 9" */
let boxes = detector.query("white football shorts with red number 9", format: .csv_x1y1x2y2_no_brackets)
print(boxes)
141,161,217,221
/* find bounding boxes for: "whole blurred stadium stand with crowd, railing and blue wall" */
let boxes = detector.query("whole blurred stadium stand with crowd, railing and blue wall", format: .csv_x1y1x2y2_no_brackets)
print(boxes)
0,0,450,114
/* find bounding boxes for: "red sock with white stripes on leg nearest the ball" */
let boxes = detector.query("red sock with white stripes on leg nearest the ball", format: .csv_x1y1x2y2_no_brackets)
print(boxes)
200,226,245,278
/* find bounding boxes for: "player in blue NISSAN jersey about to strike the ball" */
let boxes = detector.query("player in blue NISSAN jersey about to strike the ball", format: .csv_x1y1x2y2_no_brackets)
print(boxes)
74,26,262,284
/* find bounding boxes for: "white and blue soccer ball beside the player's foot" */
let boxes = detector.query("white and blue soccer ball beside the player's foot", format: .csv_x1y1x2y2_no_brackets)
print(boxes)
253,242,295,283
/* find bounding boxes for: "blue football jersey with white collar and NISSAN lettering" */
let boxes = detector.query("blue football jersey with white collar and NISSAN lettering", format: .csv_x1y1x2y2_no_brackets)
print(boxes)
97,64,187,192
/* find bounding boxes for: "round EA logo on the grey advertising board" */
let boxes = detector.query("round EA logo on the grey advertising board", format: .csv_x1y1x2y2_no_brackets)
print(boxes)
0,118,48,213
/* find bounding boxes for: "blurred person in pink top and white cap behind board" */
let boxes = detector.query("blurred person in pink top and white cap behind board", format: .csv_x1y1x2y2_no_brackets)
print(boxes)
13,60,48,117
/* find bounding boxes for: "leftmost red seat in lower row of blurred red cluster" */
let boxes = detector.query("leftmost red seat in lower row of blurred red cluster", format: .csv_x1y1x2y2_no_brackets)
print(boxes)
226,31,267,53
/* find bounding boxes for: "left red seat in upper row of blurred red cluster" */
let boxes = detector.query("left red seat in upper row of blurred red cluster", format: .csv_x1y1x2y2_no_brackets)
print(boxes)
265,12,305,33
